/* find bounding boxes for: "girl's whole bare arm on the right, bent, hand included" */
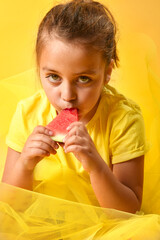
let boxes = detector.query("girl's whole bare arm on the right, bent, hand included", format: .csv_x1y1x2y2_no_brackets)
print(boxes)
64,122,143,213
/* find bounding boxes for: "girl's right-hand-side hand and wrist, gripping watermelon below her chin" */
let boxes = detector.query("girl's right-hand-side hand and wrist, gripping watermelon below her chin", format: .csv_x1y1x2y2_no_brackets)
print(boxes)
64,122,104,173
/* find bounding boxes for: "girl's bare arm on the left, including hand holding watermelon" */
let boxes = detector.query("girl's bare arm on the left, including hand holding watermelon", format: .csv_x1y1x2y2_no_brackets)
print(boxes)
2,126,58,190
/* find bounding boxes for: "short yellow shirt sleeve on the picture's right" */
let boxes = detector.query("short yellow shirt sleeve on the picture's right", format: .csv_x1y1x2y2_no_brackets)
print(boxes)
109,104,147,164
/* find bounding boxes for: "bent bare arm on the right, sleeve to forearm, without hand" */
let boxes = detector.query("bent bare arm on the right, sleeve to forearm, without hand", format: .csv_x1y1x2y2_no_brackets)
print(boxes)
90,156,144,213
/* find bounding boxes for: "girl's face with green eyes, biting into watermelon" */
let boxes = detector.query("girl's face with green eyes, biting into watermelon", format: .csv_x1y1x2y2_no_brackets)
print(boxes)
39,38,111,123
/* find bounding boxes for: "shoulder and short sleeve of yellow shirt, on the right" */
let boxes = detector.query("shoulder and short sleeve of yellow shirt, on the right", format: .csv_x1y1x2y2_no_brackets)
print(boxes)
104,86,147,164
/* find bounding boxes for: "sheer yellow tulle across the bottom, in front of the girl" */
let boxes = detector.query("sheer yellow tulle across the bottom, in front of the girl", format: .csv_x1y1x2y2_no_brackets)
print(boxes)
0,184,160,240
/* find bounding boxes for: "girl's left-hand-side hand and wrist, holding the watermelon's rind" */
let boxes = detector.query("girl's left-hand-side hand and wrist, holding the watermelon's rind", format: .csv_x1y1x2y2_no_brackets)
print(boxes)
19,126,59,170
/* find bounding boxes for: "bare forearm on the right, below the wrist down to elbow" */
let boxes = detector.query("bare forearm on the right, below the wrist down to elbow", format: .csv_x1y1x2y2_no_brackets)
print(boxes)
90,162,141,213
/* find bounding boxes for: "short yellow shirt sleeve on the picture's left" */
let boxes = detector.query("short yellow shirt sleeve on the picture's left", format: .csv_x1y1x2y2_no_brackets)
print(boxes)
6,102,28,152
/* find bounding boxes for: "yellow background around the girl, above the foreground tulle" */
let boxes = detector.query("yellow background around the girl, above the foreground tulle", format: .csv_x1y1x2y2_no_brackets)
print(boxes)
0,0,160,213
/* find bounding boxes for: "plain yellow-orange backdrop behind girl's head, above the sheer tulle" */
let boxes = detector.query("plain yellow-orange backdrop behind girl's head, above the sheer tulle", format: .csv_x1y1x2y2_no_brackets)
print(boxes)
0,0,160,80
